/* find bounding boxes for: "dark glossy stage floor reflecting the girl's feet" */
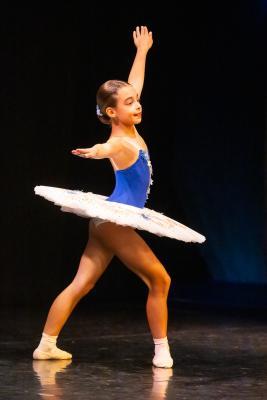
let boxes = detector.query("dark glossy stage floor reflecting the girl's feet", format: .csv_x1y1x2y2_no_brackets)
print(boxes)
0,303,267,400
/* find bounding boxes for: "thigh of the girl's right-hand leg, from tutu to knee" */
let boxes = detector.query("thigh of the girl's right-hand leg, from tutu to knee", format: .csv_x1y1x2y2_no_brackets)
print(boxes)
93,222,169,287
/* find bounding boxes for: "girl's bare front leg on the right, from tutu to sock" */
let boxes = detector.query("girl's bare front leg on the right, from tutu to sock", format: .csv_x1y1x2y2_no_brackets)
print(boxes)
91,223,170,338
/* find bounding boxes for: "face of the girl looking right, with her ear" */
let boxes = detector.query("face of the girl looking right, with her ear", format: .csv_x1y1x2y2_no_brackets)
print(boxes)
106,85,142,126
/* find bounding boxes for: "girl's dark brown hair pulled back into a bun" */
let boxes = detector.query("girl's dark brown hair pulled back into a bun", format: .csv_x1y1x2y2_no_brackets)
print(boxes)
96,79,129,125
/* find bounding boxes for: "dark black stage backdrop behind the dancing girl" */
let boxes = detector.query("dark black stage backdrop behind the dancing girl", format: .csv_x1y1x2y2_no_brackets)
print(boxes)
0,1,267,307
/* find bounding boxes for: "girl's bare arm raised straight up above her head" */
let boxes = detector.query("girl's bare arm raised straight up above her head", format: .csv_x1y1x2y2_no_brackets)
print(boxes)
128,26,153,98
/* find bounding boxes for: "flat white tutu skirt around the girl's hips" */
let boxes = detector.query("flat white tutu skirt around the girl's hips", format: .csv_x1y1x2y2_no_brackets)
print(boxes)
34,186,206,243
